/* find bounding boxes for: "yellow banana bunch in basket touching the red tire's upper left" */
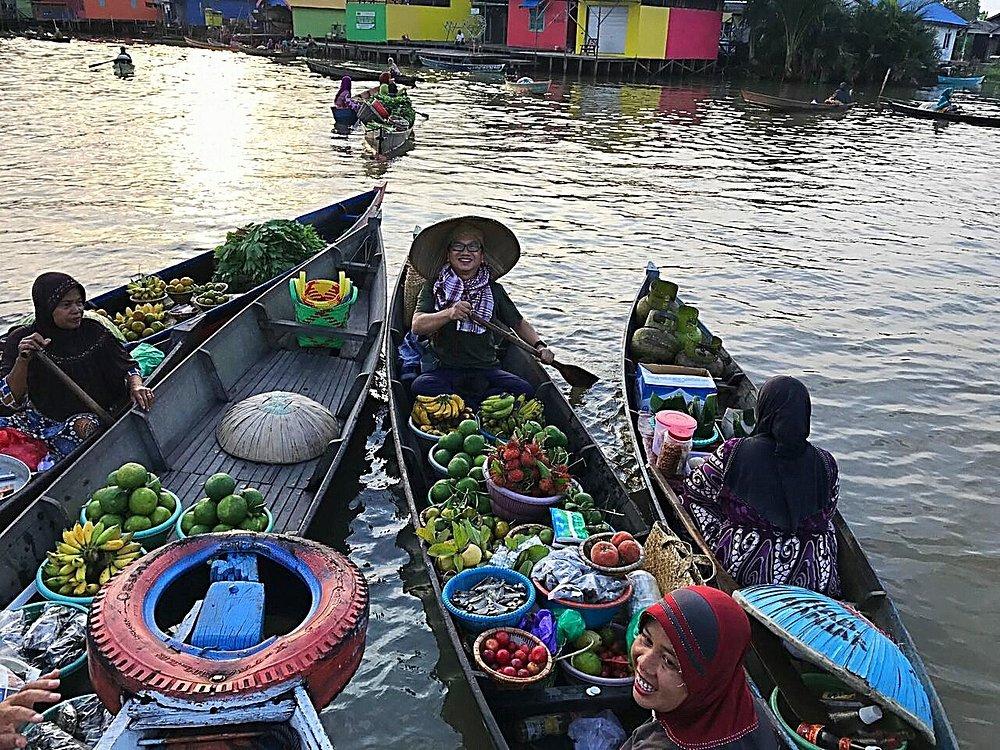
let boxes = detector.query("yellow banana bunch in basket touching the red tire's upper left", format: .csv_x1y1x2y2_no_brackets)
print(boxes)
42,521,142,596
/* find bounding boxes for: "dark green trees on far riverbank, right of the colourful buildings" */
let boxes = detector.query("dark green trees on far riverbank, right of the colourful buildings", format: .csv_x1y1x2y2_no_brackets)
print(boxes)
747,0,940,81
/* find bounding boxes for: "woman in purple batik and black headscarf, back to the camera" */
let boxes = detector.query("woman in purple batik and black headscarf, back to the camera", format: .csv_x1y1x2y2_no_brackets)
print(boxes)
682,376,840,596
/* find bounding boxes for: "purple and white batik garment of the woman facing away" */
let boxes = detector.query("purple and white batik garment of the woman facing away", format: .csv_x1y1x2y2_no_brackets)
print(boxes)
679,438,840,597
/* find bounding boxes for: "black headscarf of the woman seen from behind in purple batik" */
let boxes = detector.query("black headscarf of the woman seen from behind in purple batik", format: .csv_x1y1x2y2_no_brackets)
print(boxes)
725,375,831,532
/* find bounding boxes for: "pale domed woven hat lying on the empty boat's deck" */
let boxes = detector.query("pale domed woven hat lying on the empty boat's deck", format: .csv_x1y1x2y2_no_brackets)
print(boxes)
215,391,340,464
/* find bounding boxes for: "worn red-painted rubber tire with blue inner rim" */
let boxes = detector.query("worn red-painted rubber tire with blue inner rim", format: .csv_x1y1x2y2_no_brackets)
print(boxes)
87,532,368,712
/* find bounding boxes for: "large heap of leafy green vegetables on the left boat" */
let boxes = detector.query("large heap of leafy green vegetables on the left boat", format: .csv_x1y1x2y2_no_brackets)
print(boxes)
215,219,326,292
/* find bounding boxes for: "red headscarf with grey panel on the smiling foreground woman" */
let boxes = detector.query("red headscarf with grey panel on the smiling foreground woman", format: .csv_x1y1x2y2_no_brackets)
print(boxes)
643,586,757,750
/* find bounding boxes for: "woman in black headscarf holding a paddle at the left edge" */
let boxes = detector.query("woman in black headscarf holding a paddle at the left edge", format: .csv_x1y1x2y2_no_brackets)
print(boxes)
0,273,153,468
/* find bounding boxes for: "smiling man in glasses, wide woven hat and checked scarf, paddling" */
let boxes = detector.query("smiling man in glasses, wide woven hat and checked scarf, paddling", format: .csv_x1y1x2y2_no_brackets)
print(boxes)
410,216,555,406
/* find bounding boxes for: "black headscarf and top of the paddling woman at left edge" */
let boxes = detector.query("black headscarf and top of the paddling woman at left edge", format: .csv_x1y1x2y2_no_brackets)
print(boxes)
0,272,136,421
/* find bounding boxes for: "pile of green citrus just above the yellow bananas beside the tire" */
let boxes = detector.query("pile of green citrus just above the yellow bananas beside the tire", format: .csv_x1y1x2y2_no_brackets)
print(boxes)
84,463,177,531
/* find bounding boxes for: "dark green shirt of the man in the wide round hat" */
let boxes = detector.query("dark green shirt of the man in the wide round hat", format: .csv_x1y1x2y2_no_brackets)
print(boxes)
417,281,524,369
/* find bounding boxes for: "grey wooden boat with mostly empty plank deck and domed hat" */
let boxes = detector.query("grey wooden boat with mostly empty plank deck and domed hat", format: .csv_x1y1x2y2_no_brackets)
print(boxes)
0,204,386,602
